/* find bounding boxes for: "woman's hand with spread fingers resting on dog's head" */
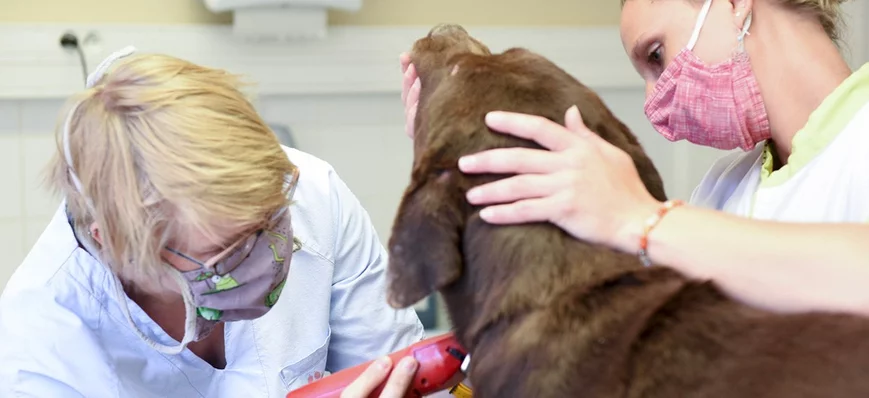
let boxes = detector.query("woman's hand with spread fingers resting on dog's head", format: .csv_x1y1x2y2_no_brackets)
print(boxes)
459,106,660,252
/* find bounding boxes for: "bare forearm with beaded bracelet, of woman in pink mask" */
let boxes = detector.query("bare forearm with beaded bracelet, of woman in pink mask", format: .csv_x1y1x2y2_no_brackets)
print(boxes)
624,206,869,316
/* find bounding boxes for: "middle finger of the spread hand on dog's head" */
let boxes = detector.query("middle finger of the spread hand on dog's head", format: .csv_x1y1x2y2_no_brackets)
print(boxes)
459,148,568,173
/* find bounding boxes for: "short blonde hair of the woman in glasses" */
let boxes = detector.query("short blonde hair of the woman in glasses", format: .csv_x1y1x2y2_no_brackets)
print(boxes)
48,54,295,294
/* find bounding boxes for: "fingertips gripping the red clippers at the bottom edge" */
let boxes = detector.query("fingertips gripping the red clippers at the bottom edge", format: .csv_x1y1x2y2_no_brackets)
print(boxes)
341,357,419,398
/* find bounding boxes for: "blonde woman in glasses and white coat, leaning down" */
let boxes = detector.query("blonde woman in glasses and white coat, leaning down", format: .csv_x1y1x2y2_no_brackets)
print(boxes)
0,49,423,398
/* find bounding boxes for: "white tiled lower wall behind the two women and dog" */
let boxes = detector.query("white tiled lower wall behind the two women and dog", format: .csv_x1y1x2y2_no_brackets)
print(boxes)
0,89,720,296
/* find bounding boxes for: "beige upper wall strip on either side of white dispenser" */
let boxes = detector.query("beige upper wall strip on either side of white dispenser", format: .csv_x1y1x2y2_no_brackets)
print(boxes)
0,0,619,25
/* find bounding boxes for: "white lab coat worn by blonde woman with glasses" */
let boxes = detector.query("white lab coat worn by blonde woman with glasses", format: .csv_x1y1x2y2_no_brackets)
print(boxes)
0,149,424,398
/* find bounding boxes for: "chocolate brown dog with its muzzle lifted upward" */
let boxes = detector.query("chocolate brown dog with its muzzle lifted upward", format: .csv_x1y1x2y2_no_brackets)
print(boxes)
389,25,869,398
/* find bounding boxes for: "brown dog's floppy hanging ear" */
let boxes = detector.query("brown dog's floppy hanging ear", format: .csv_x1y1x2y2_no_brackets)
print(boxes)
387,171,464,308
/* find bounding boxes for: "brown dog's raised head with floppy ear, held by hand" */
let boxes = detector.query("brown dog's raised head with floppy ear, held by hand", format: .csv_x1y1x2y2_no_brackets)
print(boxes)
388,25,664,307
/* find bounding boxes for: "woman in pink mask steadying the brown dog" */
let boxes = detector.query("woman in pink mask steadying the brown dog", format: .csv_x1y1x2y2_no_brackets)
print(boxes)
402,0,869,326
